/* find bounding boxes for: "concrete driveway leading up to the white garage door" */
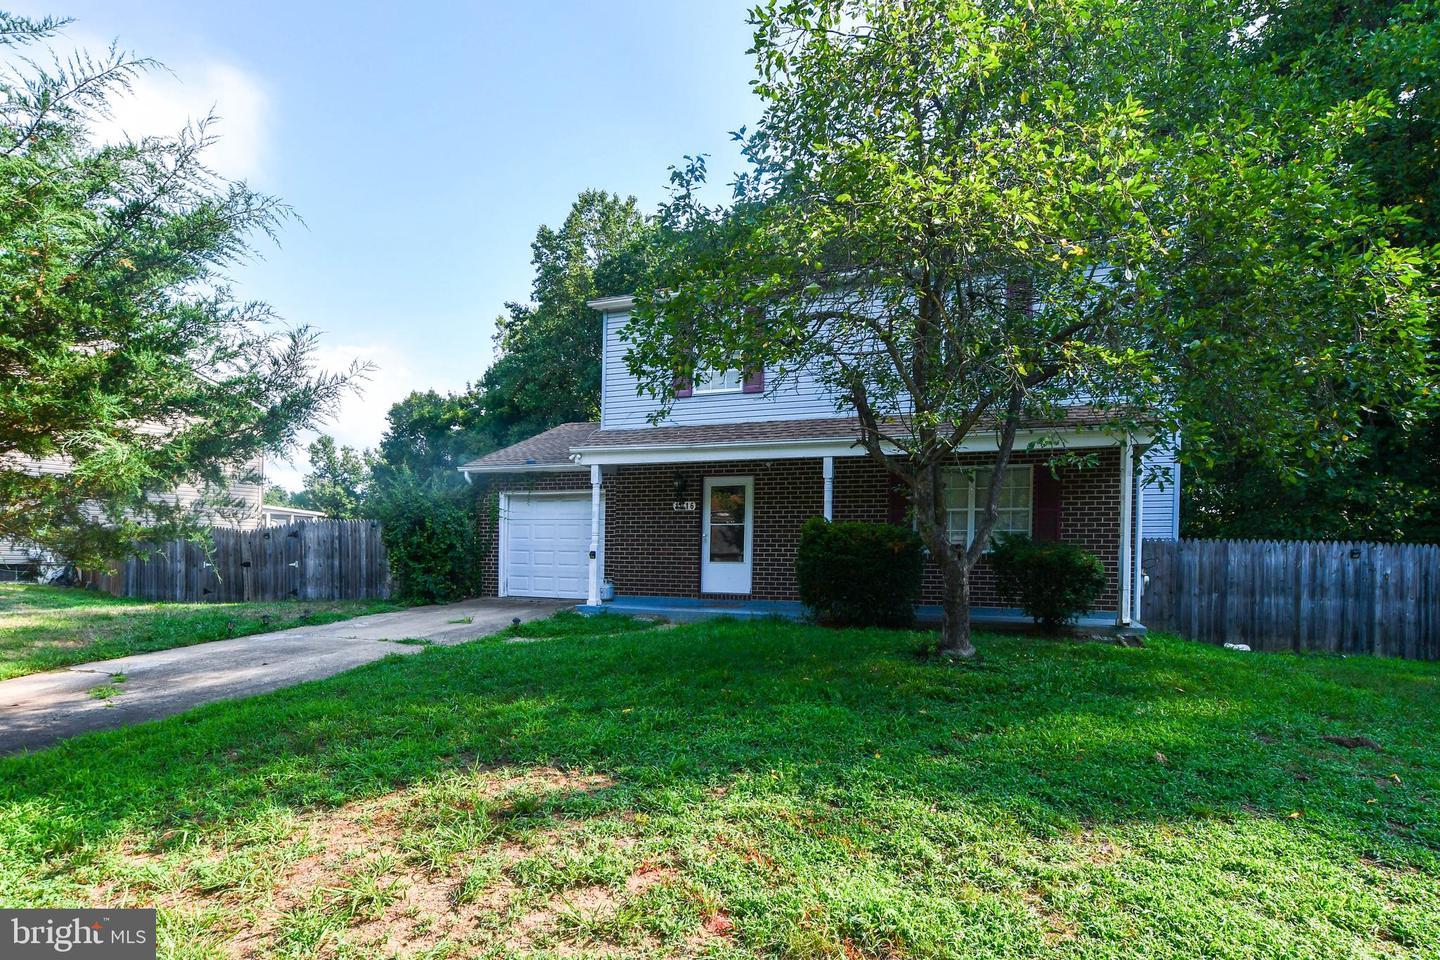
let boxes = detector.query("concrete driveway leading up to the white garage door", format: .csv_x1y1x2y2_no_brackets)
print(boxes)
0,600,575,754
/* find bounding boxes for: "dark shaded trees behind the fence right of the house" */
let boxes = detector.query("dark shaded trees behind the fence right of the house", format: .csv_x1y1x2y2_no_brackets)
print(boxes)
1182,0,1440,543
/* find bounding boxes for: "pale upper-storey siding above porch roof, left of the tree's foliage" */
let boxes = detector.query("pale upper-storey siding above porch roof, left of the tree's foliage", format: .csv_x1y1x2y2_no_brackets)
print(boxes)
600,312,845,430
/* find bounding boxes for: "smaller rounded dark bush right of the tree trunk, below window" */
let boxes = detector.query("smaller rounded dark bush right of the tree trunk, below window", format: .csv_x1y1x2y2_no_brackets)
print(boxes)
989,535,1104,633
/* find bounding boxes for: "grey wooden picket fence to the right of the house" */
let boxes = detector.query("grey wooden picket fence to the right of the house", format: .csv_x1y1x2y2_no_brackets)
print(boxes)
1140,540,1440,659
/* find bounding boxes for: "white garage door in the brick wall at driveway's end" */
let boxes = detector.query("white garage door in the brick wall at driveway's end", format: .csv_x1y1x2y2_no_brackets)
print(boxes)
504,494,590,600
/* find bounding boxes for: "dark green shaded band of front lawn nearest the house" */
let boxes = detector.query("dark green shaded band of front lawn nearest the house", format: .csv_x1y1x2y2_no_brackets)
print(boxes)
0,619,1440,869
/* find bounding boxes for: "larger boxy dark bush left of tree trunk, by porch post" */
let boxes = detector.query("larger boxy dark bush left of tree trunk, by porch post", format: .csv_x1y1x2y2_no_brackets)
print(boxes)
795,517,924,628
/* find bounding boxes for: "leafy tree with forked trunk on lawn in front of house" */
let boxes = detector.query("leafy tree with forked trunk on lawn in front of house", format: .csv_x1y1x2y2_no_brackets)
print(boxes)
626,0,1428,656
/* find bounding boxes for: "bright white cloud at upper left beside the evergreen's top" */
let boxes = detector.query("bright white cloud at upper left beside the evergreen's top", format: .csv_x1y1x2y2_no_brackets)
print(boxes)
76,40,269,180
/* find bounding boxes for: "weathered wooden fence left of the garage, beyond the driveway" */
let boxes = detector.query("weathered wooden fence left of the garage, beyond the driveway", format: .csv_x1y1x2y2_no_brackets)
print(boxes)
85,520,390,603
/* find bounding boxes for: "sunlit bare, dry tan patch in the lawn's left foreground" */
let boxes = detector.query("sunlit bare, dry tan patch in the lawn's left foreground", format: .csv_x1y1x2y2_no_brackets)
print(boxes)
96,767,674,959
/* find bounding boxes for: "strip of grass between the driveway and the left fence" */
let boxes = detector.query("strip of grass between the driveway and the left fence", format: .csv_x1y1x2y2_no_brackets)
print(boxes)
0,583,400,679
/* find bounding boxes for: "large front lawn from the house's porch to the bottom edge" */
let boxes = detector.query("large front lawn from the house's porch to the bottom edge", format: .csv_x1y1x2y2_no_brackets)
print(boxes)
0,616,1440,960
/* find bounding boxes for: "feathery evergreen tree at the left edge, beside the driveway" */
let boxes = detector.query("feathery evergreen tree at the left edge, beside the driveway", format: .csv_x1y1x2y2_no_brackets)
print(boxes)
0,13,363,564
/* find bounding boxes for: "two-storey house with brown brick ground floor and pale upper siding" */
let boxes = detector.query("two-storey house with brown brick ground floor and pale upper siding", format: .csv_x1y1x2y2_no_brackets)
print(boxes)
459,296,1178,628
